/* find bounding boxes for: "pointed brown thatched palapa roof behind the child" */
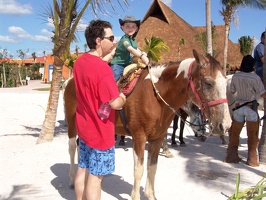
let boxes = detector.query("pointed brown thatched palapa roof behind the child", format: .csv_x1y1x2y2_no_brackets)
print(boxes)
136,0,242,70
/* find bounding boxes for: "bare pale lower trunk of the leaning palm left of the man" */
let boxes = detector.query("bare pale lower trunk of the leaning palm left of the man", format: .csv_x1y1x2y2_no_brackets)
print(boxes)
37,56,64,144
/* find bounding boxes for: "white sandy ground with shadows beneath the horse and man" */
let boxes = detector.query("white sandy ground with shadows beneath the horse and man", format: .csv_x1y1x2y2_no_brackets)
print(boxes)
0,81,266,200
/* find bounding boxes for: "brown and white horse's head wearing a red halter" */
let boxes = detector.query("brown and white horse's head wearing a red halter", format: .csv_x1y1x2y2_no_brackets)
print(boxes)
190,50,231,135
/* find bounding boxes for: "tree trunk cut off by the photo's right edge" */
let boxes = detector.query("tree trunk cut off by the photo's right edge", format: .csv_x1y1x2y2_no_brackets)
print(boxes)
258,28,266,164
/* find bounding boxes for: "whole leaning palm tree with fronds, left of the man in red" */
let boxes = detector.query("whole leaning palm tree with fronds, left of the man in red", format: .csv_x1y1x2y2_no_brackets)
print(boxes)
37,0,128,144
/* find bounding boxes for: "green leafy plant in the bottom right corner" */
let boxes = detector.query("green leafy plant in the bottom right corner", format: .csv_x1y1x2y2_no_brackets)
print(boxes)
228,174,266,200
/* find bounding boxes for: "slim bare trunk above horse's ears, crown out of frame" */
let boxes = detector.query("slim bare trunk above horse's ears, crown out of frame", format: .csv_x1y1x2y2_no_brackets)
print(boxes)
206,0,212,55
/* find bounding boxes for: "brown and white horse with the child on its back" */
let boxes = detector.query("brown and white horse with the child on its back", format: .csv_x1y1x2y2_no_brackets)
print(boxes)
64,50,230,200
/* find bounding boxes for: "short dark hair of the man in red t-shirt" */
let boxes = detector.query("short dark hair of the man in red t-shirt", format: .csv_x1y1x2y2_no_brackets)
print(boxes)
85,20,112,49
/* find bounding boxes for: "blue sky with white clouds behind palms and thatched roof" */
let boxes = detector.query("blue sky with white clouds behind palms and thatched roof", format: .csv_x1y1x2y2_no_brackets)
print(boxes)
0,0,266,58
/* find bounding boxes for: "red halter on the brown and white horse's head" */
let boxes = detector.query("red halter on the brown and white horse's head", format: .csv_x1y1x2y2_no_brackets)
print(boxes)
188,61,227,114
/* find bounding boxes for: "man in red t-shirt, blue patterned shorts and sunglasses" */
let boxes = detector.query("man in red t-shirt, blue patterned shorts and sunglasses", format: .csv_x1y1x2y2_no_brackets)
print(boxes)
74,20,126,200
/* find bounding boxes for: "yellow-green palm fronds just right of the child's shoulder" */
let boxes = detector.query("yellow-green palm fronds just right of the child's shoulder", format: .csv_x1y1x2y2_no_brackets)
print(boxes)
143,35,169,62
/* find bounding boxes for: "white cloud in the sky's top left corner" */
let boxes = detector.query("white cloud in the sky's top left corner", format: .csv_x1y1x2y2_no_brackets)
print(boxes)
0,0,32,15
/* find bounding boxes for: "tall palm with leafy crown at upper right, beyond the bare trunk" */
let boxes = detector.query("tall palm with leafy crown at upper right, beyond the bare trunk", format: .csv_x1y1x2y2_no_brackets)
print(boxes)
220,0,266,70
